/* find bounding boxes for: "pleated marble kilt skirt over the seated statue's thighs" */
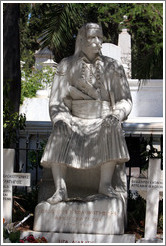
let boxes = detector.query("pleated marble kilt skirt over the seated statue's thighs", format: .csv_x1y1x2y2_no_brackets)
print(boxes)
42,114,129,169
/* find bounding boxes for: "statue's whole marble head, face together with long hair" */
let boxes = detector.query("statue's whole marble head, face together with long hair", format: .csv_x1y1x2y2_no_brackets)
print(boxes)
75,23,103,55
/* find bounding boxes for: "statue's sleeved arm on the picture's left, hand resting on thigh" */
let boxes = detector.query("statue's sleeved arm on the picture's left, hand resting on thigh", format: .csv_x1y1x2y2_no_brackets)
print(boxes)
49,58,72,126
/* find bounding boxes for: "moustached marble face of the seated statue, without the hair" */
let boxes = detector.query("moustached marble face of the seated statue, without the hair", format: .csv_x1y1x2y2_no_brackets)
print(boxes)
82,28,103,54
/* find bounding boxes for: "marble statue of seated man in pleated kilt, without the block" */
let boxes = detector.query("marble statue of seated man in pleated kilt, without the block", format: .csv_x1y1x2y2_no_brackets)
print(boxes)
41,23,132,204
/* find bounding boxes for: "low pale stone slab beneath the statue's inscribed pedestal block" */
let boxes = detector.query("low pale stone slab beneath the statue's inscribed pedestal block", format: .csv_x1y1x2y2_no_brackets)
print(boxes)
21,231,135,244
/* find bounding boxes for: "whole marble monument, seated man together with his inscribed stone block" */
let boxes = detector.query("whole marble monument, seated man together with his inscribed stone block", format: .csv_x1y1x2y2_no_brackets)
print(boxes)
34,23,134,243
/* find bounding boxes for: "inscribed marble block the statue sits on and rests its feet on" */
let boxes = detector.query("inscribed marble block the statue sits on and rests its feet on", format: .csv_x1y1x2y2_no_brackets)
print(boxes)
34,165,127,235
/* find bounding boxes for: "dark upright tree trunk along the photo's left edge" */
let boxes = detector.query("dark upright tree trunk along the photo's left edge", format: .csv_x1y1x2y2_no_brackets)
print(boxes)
3,3,21,113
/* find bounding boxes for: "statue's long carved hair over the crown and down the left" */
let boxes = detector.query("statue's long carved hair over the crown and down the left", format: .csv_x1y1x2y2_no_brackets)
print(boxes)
74,23,102,57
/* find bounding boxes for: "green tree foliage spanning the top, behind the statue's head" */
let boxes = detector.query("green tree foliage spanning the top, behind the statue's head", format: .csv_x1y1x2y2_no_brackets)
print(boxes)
20,3,163,80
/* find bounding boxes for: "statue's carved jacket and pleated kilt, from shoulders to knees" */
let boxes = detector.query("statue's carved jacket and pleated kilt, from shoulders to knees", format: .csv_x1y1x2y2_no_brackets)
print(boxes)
41,56,131,169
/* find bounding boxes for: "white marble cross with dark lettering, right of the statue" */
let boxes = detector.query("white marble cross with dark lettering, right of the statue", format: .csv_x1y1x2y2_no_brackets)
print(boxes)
130,158,163,243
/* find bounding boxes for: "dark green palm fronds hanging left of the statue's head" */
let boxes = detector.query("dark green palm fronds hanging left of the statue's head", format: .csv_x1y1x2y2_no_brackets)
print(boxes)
39,3,82,62
